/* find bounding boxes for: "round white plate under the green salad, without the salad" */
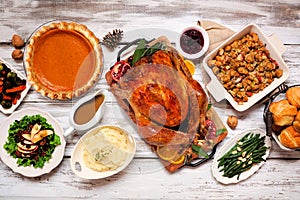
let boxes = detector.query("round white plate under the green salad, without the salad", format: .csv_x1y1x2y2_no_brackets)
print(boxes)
0,108,66,177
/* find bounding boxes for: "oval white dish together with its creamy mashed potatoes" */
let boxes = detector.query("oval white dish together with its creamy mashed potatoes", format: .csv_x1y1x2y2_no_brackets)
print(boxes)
71,125,136,179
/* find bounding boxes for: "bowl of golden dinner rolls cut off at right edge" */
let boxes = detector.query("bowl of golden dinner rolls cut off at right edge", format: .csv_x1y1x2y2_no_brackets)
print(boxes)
264,85,300,151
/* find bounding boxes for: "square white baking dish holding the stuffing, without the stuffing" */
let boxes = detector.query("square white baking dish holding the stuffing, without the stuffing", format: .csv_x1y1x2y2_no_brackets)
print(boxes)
203,24,289,112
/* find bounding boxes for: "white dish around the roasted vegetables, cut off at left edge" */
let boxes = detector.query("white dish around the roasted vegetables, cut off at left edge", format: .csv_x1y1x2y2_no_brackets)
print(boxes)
0,58,30,114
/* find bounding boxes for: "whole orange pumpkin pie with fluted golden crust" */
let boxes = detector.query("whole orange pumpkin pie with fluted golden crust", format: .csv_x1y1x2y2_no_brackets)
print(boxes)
24,22,103,100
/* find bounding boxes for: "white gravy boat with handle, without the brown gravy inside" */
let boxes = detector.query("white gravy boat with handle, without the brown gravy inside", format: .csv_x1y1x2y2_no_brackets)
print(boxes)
64,90,108,137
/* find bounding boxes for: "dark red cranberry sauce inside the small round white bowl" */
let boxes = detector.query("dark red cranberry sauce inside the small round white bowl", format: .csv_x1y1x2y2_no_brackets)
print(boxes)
180,29,204,54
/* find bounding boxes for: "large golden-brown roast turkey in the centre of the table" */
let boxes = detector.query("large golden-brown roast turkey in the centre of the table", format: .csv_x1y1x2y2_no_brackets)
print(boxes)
105,37,208,172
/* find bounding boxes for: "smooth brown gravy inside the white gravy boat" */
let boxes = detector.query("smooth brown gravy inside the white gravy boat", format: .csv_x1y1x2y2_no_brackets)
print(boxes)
74,94,104,124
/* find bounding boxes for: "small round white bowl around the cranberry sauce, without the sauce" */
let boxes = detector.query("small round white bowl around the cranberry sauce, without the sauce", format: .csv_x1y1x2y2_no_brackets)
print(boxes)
176,26,209,59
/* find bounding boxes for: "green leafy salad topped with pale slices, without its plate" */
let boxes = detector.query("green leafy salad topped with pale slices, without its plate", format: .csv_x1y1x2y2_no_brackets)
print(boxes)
4,114,61,168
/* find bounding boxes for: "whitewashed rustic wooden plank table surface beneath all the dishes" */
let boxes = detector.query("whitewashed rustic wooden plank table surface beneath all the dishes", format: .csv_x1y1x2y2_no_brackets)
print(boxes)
0,0,300,199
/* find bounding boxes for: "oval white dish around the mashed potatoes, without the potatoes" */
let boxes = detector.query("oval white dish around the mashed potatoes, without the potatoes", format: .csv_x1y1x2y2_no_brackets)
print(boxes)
70,125,136,179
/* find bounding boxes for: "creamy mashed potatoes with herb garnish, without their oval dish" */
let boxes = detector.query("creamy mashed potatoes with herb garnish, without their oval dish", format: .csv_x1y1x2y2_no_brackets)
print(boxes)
83,127,130,172
